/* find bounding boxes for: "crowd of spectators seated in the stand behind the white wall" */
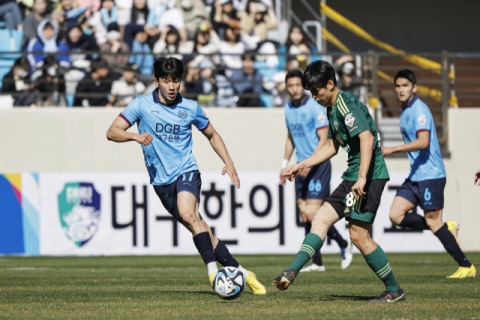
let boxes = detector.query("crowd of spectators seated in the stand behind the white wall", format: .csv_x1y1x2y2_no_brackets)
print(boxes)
0,0,362,107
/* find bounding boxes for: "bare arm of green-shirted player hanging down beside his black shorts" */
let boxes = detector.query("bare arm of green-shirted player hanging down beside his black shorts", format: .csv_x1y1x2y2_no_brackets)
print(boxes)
352,130,375,200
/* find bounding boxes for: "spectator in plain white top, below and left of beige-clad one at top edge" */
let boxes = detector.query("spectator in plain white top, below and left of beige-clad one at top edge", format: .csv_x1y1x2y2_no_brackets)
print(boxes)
219,27,245,72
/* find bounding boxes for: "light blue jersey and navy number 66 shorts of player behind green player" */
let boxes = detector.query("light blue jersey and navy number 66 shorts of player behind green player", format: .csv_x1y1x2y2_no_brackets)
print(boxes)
285,96,332,199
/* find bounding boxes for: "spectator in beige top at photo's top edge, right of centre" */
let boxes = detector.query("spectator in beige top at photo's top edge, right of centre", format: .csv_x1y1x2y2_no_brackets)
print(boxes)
238,0,278,49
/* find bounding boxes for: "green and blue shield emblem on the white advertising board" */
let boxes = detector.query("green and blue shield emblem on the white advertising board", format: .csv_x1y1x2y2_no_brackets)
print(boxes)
58,182,101,247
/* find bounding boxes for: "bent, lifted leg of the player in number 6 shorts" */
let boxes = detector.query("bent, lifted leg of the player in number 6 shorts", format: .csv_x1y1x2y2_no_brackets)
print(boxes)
390,179,428,230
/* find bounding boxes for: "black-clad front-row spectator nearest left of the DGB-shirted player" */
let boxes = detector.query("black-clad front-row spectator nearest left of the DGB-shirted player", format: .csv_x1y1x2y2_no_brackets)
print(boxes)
73,60,116,107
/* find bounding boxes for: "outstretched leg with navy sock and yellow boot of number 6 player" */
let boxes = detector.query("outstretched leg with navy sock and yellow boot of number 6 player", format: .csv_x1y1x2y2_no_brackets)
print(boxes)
425,209,477,278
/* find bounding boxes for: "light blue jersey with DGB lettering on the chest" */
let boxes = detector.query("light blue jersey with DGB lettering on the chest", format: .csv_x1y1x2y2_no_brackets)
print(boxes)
120,89,210,186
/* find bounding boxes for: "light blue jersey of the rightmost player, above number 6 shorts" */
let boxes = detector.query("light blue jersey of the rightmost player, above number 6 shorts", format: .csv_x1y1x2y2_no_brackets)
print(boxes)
400,96,447,182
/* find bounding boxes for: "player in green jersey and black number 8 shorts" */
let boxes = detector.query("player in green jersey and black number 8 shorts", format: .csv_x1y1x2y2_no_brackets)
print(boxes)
273,61,405,302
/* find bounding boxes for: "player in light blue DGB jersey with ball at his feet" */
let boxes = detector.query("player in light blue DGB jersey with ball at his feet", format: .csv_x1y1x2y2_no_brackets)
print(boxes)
107,58,266,294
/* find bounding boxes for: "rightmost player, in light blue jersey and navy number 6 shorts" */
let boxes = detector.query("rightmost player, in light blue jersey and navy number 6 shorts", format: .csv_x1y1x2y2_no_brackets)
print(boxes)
382,69,476,278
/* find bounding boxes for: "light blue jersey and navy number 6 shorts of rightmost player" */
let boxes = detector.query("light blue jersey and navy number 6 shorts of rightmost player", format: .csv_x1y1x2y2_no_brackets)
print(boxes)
397,96,447,211
